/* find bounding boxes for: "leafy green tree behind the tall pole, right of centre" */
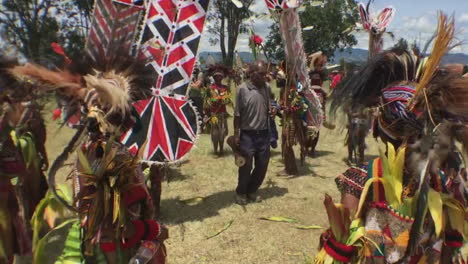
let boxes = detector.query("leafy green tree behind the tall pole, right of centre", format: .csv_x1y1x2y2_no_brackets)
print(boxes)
265,0,359,60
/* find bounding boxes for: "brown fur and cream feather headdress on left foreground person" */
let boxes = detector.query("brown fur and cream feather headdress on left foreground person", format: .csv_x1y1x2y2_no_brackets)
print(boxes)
10,47,154,119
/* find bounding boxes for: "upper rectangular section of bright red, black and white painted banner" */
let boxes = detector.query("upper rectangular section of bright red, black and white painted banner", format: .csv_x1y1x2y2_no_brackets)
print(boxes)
140,0,209,95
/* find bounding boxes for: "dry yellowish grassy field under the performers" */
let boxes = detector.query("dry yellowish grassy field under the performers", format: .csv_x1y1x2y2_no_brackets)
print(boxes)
41,81,388,264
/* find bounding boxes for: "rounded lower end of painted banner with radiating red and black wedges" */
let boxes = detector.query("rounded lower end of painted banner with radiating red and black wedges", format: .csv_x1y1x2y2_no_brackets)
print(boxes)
121,92,200,164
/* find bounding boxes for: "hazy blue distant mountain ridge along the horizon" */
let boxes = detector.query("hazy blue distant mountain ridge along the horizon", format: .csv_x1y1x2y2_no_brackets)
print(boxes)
199,48,468,64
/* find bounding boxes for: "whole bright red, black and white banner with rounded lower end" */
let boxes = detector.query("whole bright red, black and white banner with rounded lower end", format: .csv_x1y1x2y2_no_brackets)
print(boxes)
121,0,209,164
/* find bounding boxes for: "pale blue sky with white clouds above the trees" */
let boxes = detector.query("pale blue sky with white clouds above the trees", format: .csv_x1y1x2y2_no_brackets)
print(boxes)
200,0,468,54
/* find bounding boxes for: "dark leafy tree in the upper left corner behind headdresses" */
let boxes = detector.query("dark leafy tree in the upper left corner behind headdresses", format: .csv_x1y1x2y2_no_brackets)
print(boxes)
0,0,93,63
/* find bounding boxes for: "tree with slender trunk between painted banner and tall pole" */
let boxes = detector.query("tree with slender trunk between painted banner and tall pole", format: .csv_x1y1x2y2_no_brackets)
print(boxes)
207,0,254,66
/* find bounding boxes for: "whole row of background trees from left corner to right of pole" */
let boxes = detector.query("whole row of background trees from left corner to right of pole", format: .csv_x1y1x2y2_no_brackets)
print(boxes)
0,0,359,66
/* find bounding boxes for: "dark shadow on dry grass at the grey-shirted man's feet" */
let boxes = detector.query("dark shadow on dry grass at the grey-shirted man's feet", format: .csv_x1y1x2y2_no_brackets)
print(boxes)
161,186,288,224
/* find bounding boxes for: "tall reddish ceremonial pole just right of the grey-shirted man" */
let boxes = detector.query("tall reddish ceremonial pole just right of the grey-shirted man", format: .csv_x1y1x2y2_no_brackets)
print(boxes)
265,0,323,174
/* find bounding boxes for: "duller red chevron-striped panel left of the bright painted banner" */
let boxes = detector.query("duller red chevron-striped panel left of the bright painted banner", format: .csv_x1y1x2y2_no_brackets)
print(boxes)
86,0,144,60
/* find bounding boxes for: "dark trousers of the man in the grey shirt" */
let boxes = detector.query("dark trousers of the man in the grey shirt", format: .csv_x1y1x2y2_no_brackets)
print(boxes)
236,130,270,194
